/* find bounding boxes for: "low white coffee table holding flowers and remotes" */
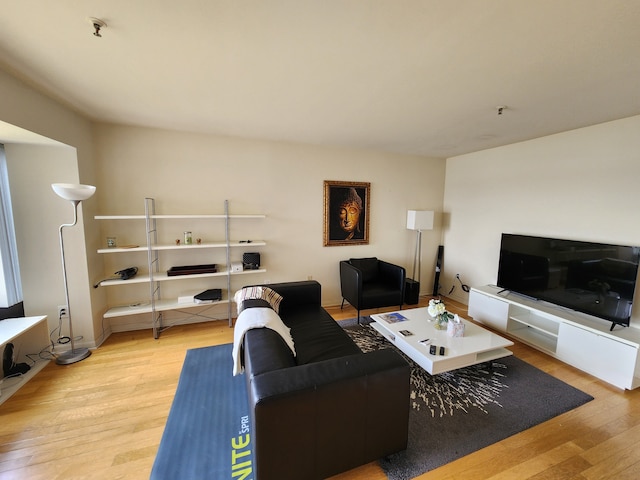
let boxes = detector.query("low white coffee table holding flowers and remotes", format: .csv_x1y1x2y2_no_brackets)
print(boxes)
371,307,513,375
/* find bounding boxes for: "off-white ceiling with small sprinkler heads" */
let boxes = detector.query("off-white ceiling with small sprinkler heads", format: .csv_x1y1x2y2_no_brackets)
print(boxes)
0,0,640,157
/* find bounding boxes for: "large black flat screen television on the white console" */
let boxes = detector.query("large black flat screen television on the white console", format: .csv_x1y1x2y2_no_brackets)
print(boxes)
498,233,640,330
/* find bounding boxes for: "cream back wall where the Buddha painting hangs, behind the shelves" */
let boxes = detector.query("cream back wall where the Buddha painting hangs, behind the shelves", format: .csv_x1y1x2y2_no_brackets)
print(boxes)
95,125,445,329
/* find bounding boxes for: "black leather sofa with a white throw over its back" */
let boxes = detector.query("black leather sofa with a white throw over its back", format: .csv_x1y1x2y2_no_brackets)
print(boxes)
243,281,410,480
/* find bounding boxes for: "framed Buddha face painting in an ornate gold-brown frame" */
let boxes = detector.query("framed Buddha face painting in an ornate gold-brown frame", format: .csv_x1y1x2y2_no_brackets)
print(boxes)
324,180,371,247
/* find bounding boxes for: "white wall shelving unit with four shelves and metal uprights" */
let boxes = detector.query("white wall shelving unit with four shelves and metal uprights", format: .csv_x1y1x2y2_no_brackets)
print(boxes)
95,198,267,338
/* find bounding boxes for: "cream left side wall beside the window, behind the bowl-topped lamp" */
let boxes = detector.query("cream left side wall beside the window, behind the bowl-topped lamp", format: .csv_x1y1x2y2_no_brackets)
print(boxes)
0,70,102,353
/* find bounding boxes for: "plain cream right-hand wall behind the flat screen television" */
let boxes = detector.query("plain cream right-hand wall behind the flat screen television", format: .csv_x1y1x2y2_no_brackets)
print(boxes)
444,116,640,326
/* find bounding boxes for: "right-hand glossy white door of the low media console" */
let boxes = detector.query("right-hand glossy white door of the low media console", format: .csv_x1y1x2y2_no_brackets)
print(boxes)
557,322,638,389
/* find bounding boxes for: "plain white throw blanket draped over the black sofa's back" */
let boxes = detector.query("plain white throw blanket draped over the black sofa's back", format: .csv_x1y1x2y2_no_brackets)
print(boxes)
231,308,296,375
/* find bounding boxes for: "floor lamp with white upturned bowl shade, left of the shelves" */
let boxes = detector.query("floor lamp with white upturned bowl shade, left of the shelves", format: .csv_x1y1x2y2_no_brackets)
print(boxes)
51,183,96,365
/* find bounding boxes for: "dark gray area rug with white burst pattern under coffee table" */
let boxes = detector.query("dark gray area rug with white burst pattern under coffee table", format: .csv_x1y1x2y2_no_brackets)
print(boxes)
339,318,593,480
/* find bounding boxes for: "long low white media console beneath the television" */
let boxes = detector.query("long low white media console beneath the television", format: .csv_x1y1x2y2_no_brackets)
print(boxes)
469,285,640,390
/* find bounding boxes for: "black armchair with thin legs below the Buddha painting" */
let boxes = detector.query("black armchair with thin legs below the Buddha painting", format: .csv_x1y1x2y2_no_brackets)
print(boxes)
340,257,406,323
